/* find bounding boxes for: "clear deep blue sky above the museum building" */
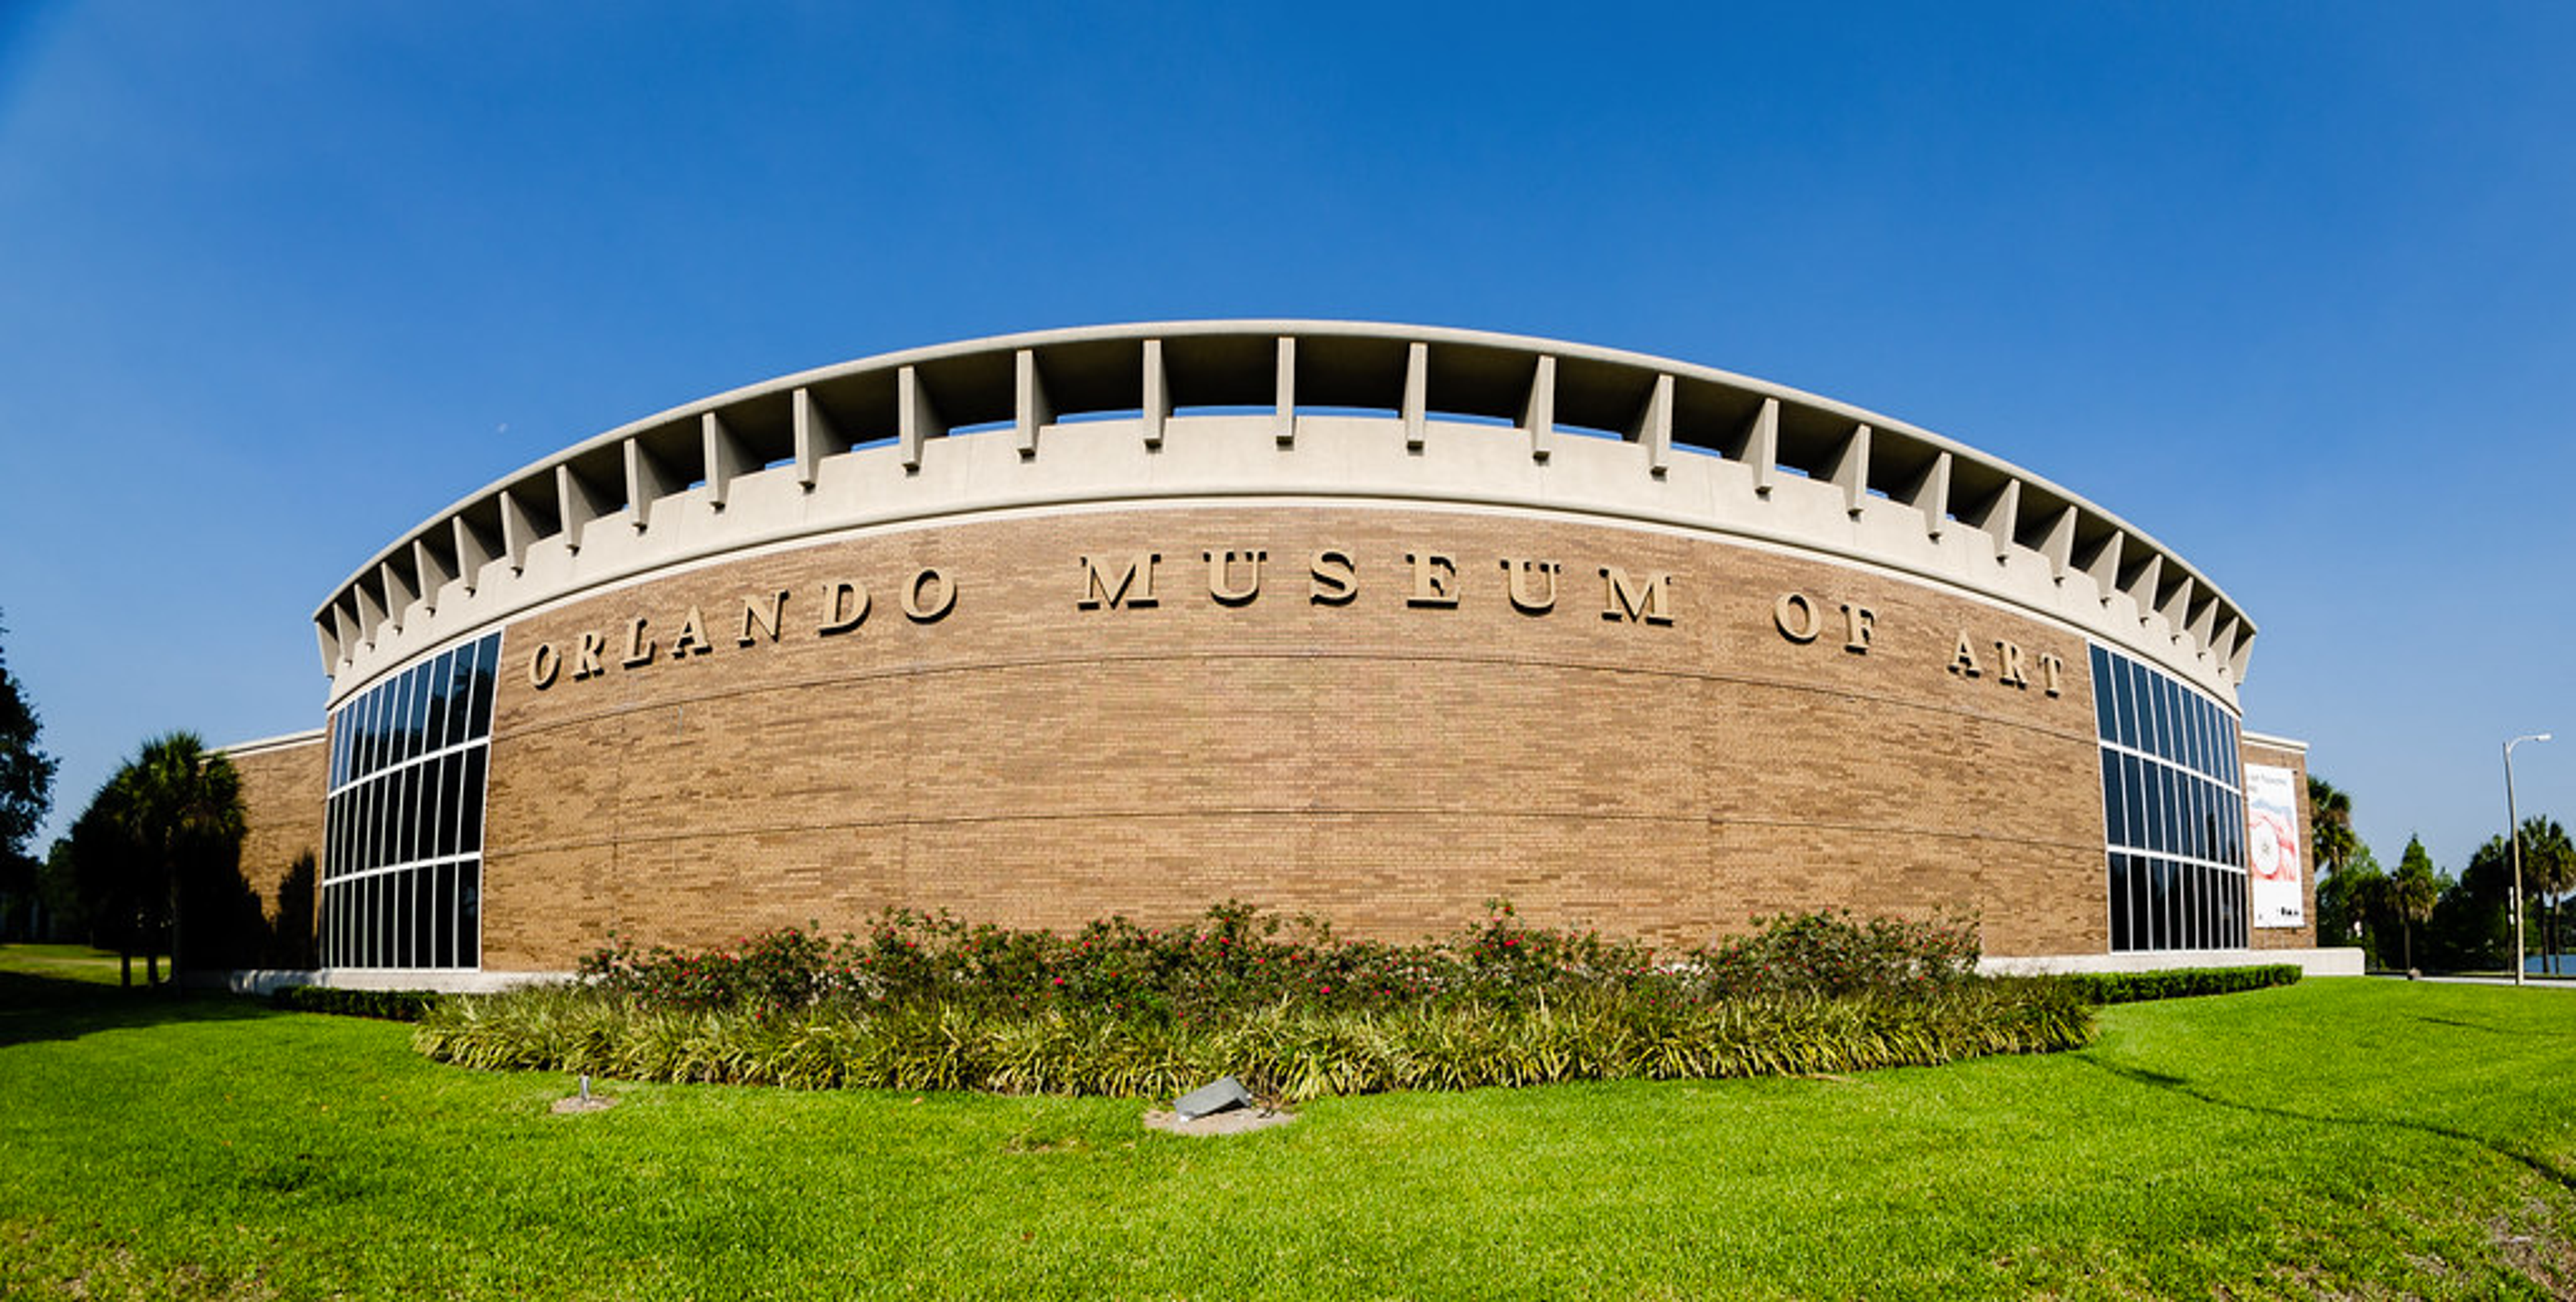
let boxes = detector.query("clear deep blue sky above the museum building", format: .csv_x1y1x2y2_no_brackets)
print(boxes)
0,0,2576,869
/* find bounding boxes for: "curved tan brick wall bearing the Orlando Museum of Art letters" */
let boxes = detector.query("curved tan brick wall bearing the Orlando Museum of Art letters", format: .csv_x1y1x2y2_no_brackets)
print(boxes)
479,505,2112,969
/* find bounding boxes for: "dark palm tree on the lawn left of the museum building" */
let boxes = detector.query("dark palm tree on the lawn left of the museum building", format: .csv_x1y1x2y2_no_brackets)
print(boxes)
103,733,245,985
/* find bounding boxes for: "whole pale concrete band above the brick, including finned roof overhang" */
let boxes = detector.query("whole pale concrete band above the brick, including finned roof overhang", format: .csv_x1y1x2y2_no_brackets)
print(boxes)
314,320,2254,701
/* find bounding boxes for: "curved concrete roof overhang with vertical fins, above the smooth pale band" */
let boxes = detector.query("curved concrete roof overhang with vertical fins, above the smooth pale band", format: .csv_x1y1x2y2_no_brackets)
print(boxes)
314,320,2254,678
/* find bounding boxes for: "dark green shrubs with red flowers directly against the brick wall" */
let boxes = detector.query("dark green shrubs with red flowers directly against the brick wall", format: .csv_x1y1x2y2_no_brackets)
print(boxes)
580,900,1978,1018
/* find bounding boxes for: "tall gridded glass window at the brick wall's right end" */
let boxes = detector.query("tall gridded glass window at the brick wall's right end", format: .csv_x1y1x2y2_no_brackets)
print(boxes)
2092,647,2251,951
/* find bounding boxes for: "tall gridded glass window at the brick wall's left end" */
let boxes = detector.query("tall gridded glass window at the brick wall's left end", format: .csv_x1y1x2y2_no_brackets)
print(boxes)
319,635,500,967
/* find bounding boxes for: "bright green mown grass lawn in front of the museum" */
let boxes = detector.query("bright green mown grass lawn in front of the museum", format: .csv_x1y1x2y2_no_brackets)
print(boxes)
0,948,2576,1297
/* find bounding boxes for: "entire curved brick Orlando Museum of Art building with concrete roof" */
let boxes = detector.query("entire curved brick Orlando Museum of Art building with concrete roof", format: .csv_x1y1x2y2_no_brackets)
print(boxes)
229,320,2359,987
